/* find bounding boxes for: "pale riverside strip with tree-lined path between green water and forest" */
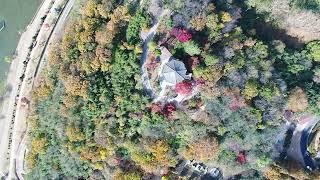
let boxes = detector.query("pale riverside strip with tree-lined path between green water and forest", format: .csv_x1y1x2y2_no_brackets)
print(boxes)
0,0,74,179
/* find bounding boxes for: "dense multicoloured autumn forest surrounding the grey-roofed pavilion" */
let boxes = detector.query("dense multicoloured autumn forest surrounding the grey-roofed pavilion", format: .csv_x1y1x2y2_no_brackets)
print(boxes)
26,0,320,180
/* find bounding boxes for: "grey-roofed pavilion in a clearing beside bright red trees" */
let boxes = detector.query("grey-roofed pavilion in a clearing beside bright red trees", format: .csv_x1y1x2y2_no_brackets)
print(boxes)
161,57,191,86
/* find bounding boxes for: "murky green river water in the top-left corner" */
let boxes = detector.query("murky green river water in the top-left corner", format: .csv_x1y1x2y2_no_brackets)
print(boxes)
0,0,42,93
